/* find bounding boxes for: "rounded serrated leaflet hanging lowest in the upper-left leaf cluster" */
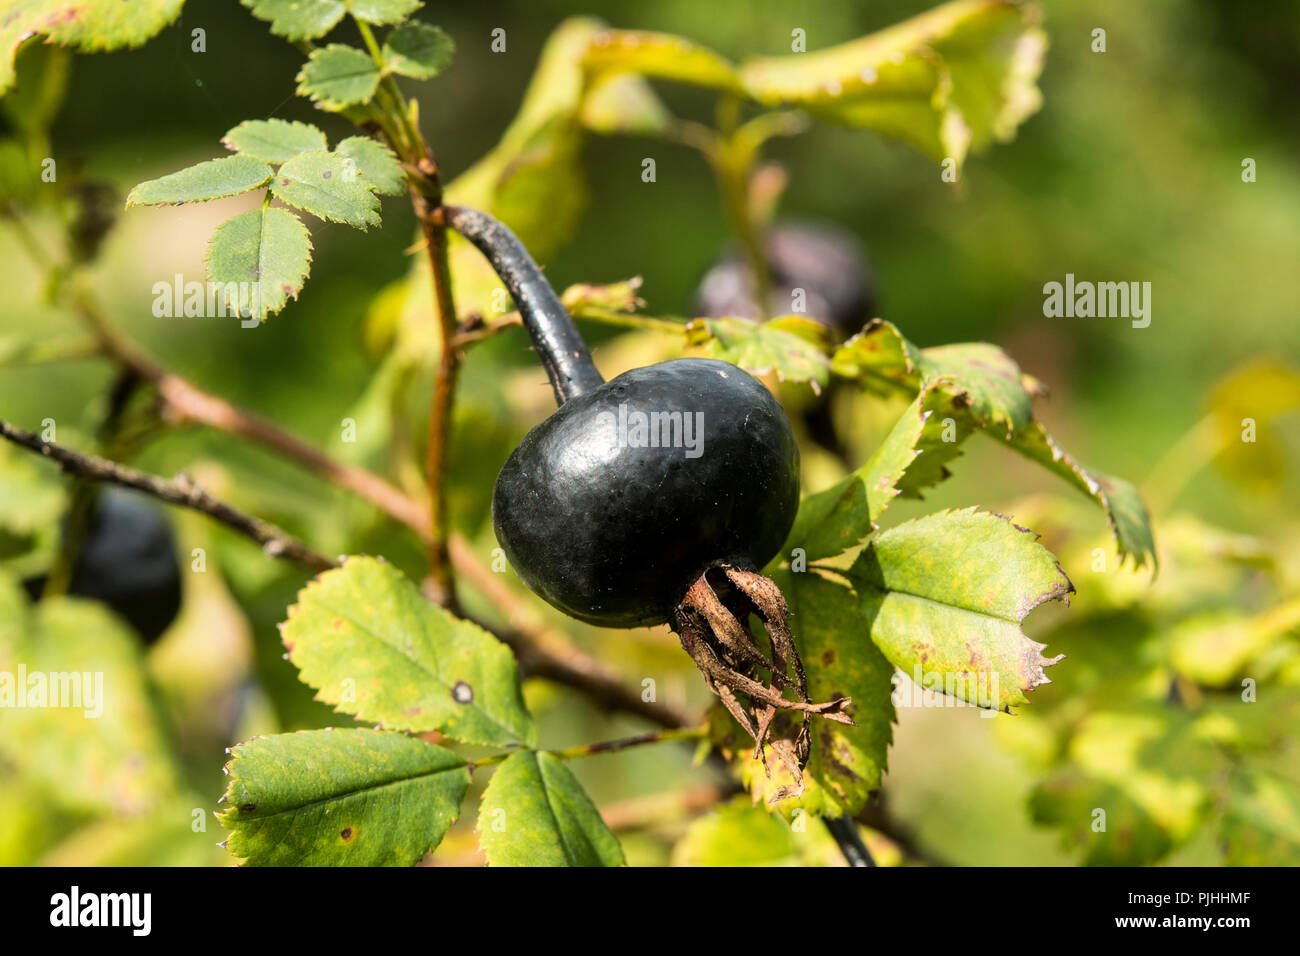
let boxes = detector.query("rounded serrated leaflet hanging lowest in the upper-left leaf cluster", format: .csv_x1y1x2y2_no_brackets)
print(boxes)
208,207,312,319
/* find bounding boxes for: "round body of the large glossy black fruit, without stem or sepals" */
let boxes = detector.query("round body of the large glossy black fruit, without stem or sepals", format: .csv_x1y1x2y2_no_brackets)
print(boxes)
493,359,800,627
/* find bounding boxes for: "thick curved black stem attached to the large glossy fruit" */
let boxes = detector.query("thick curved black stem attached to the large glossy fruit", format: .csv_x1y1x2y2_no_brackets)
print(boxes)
442,206,605,405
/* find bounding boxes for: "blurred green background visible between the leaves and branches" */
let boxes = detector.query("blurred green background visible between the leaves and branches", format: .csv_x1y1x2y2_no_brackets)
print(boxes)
0,0,1300,865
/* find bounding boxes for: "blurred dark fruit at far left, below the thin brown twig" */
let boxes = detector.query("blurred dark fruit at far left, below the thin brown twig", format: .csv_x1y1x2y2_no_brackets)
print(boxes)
26,488,181,644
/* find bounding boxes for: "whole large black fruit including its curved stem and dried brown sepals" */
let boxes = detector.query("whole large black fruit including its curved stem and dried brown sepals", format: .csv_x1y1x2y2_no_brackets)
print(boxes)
442,207,853,777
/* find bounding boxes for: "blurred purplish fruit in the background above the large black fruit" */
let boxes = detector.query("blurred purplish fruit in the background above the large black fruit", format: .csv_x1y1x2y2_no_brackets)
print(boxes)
693,224,875,337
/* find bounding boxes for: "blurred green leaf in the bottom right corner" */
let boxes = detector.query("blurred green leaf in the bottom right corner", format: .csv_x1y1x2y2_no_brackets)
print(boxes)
1219,771,1300,866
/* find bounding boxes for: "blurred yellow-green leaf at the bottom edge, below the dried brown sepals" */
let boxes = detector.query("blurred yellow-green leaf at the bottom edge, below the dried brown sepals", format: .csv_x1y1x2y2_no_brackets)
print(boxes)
672,797,844,866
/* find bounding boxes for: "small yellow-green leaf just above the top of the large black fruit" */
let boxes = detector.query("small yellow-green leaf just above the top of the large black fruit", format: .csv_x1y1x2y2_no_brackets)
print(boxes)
685,315,831,393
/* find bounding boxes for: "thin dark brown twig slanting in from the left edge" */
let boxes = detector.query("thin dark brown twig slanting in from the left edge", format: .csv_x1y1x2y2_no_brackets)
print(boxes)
0,421,335,571
